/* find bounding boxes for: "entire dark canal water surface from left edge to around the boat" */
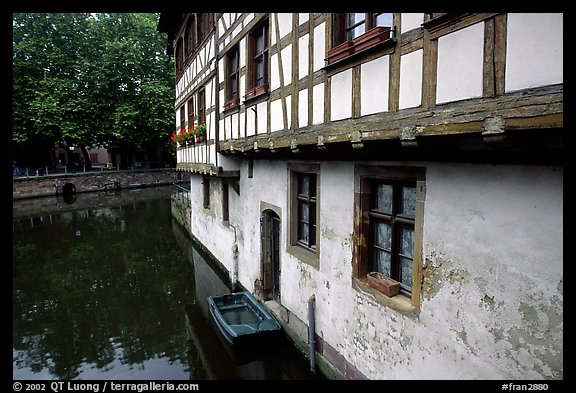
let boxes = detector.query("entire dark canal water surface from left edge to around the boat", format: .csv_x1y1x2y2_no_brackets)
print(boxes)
12,187,322,380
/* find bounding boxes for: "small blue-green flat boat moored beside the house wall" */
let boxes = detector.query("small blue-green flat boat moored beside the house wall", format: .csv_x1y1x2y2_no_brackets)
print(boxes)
208,291,281,345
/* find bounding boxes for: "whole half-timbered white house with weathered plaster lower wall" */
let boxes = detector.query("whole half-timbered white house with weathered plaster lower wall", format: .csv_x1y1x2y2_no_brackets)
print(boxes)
158,13,563,379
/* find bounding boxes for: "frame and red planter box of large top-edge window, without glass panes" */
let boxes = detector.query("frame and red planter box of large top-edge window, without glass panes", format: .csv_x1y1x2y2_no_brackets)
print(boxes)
326,13,395,65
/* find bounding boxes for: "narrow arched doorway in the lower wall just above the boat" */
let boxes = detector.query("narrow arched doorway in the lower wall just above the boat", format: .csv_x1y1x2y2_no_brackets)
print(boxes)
256,209,280,302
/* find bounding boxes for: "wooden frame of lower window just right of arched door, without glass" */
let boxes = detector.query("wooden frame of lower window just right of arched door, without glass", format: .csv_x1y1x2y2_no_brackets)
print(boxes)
287,163,320,269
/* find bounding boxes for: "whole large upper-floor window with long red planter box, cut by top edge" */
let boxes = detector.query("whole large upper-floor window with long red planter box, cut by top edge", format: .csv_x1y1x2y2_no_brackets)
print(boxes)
326,12,394,64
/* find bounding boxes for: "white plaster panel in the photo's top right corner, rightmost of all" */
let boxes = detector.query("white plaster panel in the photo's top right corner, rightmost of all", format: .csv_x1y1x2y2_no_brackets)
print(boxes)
505,13,564,92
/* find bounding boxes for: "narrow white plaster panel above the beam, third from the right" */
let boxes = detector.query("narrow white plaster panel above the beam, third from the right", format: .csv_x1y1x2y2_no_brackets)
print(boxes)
399,49,423,109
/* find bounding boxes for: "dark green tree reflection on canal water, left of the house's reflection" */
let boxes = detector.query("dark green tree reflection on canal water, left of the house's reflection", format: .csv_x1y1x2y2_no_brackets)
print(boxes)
12,190,194,379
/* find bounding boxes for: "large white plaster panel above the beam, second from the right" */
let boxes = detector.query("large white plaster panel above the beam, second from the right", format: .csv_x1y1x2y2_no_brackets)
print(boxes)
436,23,484,104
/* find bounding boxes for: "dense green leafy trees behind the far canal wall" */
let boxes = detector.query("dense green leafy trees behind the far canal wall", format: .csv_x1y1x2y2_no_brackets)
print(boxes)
13,13,174,167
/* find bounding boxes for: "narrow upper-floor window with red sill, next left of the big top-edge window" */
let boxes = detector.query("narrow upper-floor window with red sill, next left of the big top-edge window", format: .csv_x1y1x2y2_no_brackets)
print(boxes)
246,20,268,98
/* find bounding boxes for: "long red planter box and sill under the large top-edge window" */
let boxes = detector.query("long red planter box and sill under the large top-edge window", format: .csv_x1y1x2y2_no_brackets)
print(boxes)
326,26,396,67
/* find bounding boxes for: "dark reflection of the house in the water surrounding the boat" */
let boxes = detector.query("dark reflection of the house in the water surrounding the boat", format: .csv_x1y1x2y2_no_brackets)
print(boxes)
172,217,322,380
